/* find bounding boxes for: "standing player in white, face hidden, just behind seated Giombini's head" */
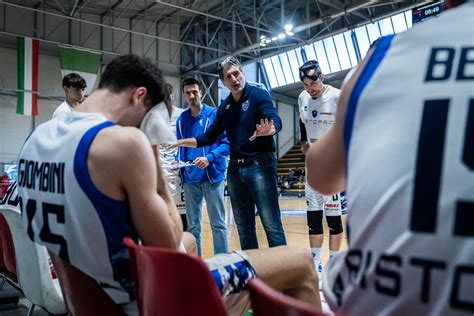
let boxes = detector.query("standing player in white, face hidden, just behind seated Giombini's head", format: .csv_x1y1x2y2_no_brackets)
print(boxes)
140,83,188,230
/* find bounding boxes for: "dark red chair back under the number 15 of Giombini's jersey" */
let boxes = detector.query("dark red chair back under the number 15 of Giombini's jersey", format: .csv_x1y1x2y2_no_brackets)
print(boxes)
49,251,125,316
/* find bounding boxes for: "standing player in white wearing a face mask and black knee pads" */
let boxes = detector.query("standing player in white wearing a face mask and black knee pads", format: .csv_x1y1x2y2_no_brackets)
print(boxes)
298,60,343,273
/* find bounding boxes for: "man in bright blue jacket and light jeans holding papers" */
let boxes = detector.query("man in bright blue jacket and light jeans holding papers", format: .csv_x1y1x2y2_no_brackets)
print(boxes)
176,78,229,256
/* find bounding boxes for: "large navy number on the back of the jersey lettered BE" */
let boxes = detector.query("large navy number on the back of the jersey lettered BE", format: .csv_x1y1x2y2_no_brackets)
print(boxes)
410,99,474,237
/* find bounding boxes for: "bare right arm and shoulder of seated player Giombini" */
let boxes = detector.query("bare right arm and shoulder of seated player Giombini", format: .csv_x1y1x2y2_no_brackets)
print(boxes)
88,127,183,249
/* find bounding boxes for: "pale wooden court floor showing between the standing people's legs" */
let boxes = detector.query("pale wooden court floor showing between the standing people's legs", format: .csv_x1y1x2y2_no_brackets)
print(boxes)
202,197,347,263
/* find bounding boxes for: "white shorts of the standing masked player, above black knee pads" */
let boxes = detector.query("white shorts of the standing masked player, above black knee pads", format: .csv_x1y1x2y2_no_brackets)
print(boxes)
304,182,342,216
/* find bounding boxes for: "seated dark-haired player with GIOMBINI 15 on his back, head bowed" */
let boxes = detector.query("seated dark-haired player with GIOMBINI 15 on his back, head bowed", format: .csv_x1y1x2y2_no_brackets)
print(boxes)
18,55,320,313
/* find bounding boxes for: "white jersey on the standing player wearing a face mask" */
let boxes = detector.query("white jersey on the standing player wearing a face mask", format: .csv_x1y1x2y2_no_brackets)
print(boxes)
298,85,341,143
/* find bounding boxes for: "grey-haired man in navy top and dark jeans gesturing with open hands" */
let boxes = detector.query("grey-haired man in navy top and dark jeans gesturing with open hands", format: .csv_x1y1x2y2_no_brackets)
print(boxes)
177,56,286,250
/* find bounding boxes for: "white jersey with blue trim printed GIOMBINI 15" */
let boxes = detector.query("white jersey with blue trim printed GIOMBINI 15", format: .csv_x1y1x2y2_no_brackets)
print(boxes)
18,111,137,303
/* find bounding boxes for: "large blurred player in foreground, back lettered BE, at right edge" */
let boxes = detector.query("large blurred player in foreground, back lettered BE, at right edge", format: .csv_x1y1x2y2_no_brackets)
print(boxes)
307,1,474,315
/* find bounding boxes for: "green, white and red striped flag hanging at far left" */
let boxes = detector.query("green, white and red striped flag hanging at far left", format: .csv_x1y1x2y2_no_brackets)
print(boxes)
16,37,39,115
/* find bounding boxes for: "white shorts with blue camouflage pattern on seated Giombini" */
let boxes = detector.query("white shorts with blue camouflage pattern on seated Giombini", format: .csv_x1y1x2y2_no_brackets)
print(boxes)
204,250,257,315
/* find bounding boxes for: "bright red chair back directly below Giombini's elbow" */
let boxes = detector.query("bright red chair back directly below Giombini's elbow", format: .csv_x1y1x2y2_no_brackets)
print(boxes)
124,238,228,316
